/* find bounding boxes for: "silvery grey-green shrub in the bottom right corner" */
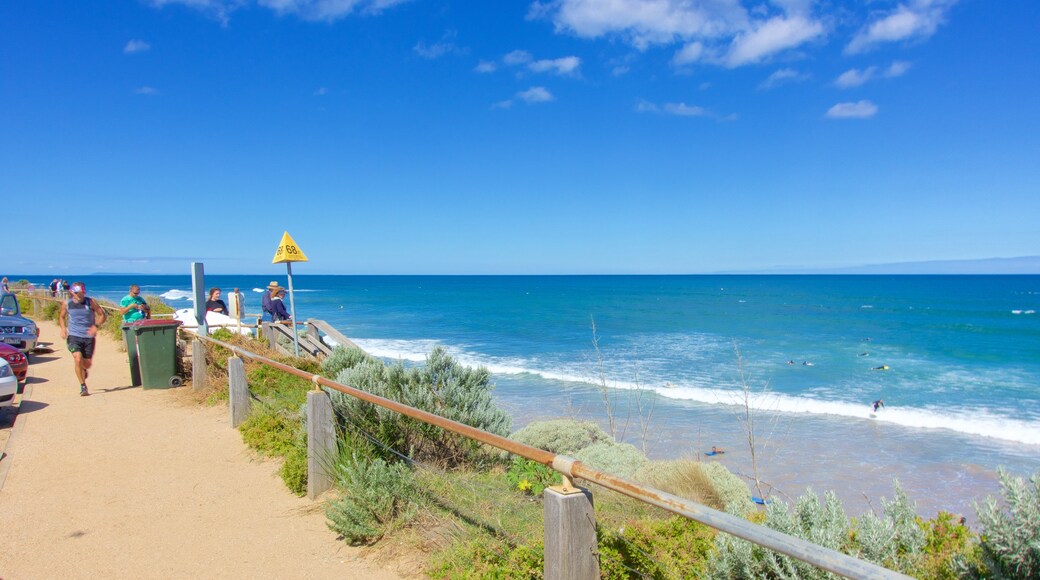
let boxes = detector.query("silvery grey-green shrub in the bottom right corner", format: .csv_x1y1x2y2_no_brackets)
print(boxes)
961,468,1040,578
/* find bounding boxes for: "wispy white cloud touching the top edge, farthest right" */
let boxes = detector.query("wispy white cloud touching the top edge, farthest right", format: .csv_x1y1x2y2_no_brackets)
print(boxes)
844,0,957,54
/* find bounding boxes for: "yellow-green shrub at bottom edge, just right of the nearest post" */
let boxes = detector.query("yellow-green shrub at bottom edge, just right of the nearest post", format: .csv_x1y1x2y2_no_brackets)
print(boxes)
596,516,716,578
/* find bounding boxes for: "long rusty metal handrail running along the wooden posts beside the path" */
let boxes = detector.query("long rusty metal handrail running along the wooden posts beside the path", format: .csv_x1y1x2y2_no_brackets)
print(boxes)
198,336,909,579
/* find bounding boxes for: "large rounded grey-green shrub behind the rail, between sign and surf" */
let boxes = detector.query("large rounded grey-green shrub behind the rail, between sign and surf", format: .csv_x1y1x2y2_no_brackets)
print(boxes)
332,348,511,468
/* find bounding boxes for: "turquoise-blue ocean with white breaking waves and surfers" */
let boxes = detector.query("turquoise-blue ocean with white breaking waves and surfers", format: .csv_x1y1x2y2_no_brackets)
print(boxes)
28,274,1040,521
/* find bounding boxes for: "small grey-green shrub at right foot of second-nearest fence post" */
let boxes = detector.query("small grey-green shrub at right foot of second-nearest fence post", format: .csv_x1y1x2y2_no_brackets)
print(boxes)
326,456,418,545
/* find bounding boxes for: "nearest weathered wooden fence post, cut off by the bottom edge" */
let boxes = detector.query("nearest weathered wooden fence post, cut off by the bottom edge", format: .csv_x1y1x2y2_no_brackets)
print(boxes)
542,485,599,580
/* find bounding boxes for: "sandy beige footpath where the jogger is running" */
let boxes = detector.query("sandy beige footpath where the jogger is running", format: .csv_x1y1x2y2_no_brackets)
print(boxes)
0,321,397,580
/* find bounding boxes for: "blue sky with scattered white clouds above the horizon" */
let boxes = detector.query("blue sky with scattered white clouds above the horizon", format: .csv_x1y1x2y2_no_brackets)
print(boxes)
0,0,1040,275
